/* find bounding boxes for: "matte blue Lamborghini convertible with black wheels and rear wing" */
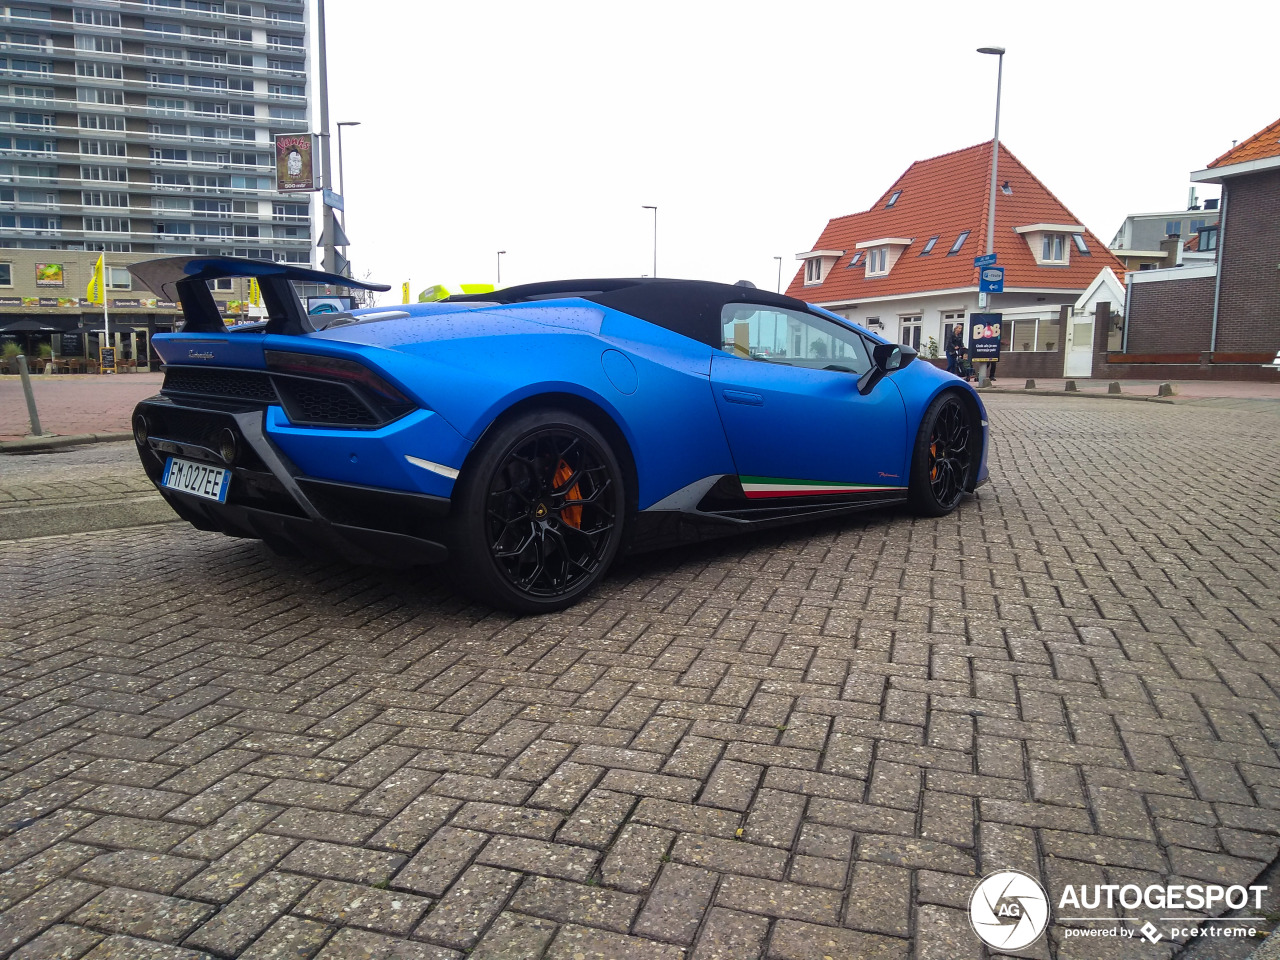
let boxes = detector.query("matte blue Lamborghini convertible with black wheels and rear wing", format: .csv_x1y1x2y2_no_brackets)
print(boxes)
129,257,987,612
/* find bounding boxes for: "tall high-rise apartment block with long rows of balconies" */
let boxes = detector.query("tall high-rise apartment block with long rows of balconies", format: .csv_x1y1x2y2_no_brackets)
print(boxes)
0,0,314,264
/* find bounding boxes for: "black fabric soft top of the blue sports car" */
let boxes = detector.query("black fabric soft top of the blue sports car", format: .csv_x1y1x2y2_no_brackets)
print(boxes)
449,276,810,347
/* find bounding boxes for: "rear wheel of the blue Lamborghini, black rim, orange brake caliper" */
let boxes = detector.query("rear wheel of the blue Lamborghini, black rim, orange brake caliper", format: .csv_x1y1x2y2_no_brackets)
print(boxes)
451,408,626,613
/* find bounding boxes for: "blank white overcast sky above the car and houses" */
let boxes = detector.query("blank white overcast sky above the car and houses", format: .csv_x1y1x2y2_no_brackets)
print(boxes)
316,0,1259,303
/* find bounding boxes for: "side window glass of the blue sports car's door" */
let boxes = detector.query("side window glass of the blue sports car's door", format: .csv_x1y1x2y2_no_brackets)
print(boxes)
721,303,870,375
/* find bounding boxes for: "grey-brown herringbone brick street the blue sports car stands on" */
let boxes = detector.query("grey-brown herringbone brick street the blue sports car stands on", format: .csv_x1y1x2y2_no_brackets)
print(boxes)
0,396,1280,960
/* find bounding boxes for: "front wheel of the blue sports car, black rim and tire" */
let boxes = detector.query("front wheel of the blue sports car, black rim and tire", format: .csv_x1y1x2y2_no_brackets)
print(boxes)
908,390,980,517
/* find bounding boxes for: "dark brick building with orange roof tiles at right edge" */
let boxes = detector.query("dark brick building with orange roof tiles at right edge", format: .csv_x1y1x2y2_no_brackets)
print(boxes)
1126,120,1280,380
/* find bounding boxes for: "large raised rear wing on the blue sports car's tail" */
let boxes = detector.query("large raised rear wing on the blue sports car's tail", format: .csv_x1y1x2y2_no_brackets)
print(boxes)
129,256,390,334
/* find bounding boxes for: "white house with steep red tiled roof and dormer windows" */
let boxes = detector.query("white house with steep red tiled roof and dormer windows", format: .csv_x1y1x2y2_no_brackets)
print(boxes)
787,142,1124,376
